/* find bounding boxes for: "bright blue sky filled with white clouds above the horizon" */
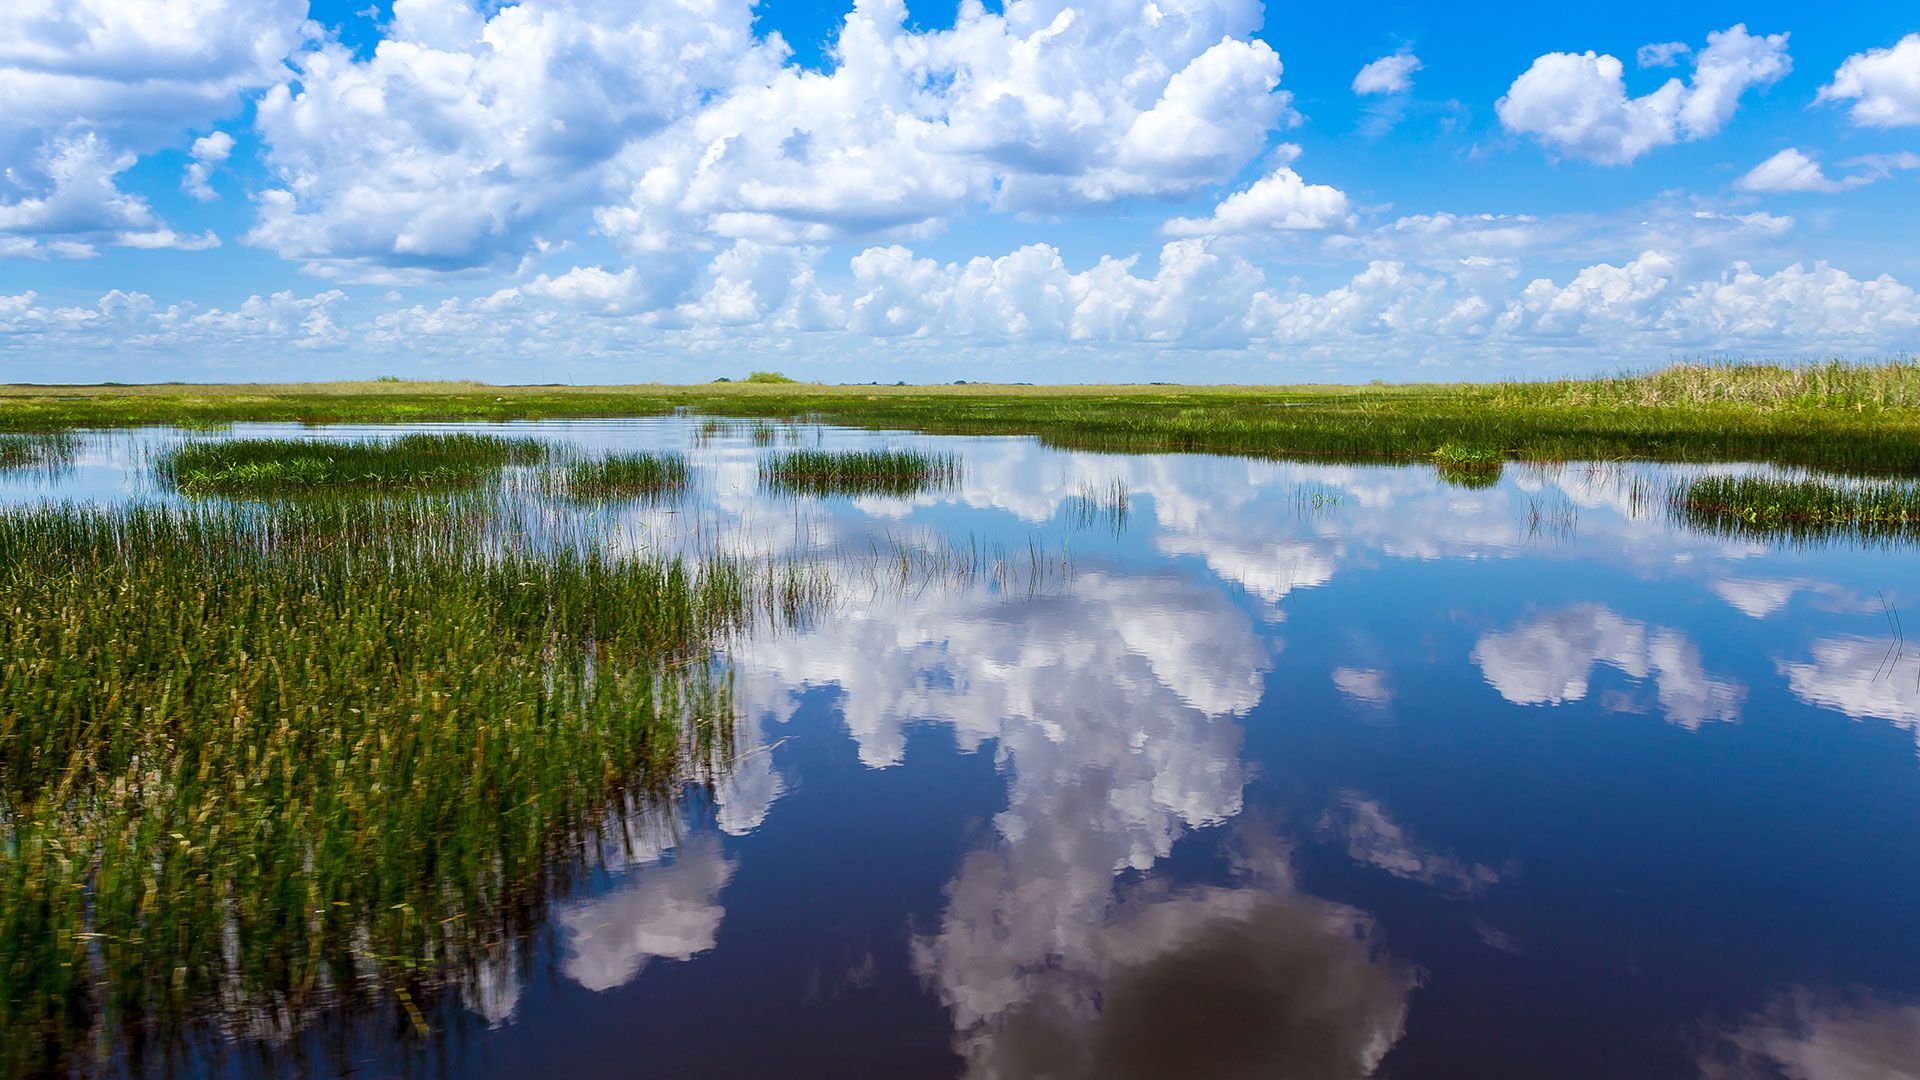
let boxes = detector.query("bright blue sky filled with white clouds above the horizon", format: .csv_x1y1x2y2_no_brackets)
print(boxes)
0,0,1920,382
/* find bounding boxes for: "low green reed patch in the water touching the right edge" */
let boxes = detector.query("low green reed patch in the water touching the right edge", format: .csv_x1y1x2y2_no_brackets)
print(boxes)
1667,477,1920,540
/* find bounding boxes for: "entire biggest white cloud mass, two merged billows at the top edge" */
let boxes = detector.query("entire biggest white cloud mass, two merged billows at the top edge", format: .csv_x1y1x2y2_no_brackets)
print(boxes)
250,0,1292,274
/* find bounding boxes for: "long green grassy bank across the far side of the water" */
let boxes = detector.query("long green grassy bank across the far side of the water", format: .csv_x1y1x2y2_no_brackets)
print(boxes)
0,361,1920,475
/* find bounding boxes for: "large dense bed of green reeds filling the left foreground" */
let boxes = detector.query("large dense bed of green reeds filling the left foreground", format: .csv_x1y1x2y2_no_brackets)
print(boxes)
0,500,783,1074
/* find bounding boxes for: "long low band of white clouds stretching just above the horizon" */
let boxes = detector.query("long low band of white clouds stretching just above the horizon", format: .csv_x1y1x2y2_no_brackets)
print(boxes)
15,239,1920,368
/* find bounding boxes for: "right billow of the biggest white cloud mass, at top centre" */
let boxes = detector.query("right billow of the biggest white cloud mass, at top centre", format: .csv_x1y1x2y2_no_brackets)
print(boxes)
597,0,1292,250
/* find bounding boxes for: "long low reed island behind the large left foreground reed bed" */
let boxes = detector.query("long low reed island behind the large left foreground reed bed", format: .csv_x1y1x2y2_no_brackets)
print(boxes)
154,434,547,498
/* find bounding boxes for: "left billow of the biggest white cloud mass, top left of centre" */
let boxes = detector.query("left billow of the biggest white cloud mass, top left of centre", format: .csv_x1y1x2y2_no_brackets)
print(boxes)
248,0,778,279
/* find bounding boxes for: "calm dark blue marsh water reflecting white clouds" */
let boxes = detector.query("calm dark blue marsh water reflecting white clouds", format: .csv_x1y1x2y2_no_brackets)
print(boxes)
0,417,1920,1078
